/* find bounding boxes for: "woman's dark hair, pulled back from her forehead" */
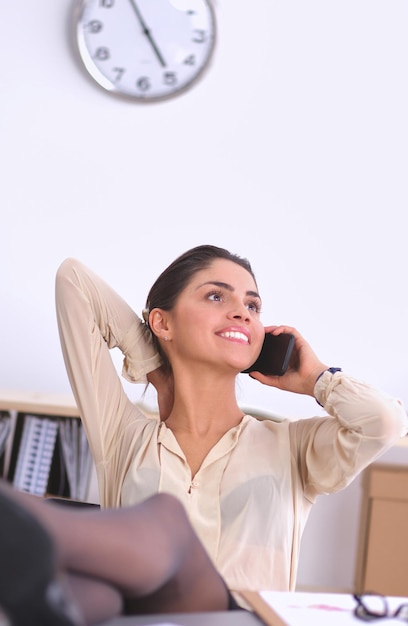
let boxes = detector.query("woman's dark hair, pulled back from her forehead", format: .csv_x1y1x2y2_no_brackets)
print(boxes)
146,245,256,371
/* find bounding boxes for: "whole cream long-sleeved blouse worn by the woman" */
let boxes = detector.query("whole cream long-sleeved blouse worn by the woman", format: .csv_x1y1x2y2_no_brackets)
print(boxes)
56,259,407,590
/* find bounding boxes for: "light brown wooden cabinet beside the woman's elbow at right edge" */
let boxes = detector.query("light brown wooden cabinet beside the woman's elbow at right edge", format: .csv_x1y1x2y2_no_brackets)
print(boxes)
356,463,408,596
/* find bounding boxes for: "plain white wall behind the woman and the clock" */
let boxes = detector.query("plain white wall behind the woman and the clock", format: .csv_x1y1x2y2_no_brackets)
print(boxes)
0,0,408,587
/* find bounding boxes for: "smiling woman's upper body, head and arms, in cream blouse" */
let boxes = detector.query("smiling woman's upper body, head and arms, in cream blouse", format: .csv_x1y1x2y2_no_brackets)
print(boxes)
56,246,407,590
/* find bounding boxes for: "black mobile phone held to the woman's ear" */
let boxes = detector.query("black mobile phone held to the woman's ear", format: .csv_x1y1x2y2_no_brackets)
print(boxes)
242,333,295,376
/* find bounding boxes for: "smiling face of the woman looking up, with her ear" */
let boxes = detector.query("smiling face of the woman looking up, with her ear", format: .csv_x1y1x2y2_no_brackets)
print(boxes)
167,259,265,373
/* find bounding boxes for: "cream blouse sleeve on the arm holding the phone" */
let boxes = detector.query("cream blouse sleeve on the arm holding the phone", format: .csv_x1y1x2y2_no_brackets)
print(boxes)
290,372,408,499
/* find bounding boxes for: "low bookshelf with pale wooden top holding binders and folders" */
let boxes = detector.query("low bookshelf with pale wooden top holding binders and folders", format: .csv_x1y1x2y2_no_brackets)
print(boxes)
0,390,93,501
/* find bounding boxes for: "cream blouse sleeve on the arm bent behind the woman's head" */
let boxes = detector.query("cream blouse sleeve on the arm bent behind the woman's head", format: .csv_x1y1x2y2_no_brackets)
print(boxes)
56,259,160,463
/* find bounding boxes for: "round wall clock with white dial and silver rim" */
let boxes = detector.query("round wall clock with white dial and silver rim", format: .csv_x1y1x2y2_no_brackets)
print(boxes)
74,0,215,102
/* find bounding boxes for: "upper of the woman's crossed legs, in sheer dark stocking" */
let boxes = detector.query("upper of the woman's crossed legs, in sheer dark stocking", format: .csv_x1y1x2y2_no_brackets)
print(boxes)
2,486,228,617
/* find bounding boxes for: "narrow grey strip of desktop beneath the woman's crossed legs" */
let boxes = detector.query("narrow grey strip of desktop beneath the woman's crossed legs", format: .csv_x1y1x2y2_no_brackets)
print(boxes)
100,611,263,626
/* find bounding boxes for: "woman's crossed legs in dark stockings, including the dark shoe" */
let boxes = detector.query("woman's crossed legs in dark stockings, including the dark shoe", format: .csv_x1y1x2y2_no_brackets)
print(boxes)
0,481,236,626
